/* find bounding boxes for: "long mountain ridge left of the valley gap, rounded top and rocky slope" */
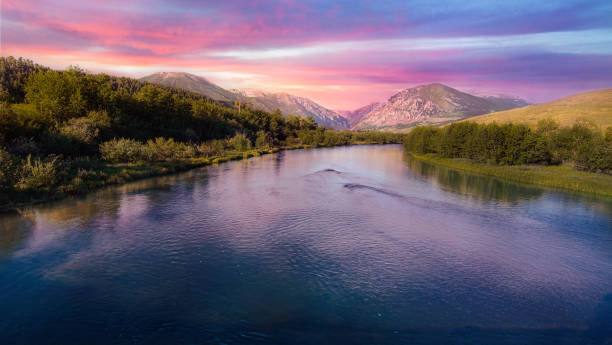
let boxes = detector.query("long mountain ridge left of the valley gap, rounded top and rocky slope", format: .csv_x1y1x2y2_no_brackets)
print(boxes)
141,72,349,129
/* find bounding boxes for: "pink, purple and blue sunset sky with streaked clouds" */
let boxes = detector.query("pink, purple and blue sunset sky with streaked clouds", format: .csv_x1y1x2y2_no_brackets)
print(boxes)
0,0,612,110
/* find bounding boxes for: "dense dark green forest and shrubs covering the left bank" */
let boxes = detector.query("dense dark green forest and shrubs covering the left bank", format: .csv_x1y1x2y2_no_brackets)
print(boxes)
0,57,403,208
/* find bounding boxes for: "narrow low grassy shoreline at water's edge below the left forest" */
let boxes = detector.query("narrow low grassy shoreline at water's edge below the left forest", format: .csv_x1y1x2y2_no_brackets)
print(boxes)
0,142,392,214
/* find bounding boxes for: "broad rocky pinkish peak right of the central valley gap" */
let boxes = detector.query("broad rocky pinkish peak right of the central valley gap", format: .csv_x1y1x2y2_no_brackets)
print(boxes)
353,83,520,129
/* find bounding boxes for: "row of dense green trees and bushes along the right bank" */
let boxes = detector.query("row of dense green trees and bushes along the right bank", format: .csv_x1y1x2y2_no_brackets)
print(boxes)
404,120,612,173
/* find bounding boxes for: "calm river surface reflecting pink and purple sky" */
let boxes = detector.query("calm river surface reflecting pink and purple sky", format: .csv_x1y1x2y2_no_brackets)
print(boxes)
0,146,612,344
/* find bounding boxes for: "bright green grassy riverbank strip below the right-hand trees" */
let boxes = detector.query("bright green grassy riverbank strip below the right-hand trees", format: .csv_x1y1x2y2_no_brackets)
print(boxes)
411,154,612,196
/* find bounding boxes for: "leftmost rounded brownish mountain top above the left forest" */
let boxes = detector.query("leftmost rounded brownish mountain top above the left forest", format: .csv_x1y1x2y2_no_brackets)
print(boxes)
140,72,236,102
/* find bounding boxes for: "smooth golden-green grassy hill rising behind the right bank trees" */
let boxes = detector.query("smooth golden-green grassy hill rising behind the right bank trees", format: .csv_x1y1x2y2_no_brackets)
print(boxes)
469,89,612,129
